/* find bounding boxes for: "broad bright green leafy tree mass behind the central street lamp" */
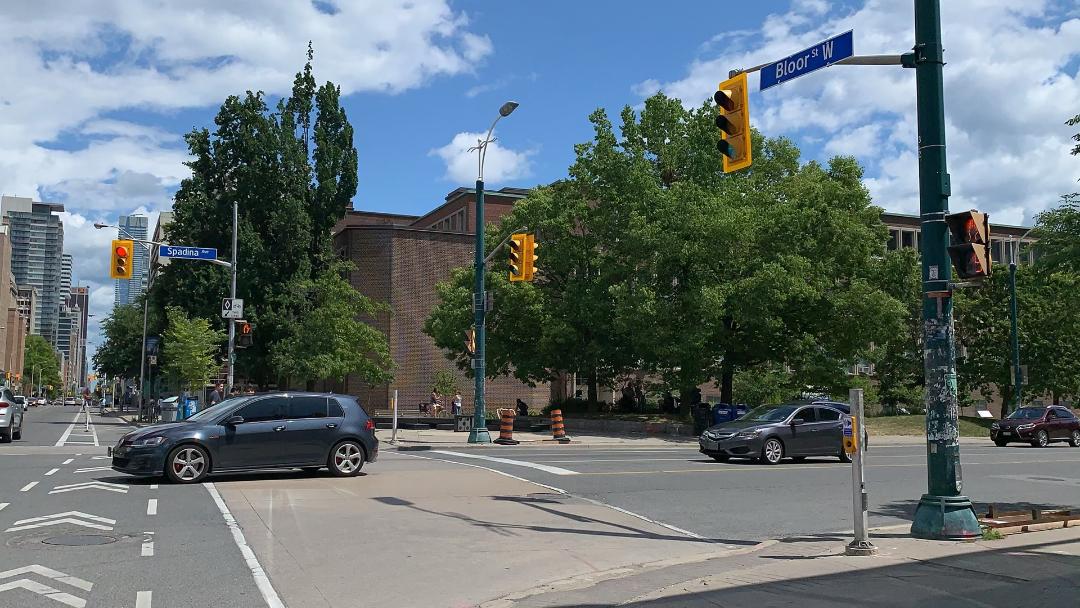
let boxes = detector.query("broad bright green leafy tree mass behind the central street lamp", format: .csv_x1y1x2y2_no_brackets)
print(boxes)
426,95,903,402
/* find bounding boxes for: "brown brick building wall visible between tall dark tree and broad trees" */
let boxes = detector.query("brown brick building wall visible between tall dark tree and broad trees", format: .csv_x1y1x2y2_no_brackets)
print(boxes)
327,188,550,411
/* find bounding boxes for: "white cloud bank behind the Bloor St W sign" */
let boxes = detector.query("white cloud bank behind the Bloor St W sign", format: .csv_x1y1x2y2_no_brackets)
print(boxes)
632,0,1080,224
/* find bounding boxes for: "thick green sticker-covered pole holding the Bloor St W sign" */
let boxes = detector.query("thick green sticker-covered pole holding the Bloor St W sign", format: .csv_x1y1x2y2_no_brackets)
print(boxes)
912,0,981,540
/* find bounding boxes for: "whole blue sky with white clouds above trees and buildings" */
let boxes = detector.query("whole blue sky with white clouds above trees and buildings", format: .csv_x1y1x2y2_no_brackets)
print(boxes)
0,0,1080,360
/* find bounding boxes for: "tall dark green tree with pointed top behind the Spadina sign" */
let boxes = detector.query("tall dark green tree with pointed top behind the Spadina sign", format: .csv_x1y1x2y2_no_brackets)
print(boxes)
153,44,386,386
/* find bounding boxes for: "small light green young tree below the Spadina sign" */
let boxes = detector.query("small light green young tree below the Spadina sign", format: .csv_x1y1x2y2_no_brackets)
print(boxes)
162,307,225,391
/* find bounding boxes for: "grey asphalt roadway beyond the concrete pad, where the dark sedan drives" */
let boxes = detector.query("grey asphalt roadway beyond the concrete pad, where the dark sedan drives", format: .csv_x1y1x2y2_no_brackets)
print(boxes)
408,441,1080,542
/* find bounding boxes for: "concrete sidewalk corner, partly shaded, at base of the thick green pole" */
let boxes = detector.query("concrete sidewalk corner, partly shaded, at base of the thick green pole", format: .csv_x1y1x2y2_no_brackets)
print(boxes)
492,528,1080,608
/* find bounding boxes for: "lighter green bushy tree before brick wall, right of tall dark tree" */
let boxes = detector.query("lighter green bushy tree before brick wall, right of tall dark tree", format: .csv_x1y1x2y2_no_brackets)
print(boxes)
272,262,393,390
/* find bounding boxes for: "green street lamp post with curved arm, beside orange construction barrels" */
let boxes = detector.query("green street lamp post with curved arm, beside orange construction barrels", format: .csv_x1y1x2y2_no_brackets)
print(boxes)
469,102,517,444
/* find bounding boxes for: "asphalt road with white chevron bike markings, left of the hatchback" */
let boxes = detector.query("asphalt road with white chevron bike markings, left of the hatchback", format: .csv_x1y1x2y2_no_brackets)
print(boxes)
0,406,267,608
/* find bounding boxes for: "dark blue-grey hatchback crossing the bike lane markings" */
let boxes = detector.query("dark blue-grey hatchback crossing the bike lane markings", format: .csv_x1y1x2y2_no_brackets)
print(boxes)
109,392,379,484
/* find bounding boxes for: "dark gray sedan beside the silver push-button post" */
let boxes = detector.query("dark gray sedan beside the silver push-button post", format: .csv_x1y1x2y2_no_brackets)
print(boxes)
699,402,851,464
